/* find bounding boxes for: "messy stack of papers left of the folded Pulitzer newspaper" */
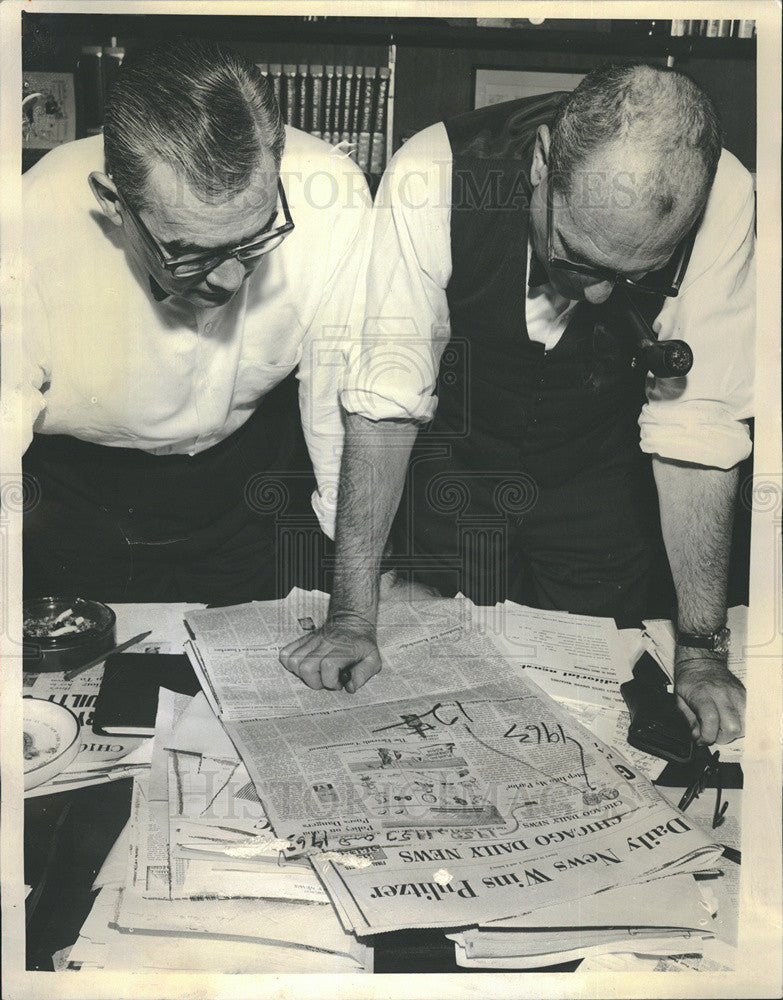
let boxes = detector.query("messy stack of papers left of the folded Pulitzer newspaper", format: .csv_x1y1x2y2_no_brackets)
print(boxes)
59,676,372,973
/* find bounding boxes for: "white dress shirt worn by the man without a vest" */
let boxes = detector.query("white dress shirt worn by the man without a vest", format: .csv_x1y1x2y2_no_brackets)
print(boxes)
13,128,371,535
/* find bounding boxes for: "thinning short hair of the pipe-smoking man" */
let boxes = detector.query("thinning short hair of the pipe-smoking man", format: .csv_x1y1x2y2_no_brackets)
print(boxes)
548,62,723,218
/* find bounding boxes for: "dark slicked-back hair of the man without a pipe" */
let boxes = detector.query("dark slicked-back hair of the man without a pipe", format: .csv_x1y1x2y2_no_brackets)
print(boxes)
103,38,285,209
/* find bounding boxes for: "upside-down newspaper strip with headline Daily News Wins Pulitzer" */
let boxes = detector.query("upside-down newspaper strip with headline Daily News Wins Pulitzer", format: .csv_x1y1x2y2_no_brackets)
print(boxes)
311,803,720,936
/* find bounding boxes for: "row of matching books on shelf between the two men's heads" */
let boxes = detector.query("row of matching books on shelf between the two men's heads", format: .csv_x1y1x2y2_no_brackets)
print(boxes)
258,63,390,174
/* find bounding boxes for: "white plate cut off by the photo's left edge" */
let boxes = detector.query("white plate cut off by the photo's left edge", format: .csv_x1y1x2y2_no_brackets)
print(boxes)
23,698,81,790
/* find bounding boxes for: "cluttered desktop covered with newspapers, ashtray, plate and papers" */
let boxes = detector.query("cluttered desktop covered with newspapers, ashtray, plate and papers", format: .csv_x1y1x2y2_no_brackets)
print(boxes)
23,589,747,973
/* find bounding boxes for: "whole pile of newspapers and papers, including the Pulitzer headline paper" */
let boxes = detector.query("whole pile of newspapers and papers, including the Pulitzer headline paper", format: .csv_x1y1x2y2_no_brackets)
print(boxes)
69,590,722,972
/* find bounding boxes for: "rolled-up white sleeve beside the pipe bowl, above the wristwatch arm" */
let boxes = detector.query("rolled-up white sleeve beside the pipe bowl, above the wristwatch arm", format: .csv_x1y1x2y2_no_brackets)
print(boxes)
639,150,756,469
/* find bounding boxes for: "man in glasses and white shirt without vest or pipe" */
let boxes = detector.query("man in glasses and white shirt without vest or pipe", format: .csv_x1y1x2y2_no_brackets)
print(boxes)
18,40,370,604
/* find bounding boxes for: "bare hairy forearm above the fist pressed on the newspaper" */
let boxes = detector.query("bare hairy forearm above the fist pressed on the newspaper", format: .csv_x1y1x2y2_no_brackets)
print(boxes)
329,413,418,625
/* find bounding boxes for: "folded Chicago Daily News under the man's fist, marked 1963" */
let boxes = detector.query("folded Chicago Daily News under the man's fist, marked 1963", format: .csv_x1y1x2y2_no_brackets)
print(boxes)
187,591,721,935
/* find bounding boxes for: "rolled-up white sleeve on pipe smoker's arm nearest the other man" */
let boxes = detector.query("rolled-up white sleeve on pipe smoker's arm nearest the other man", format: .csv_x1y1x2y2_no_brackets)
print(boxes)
341,123,451,422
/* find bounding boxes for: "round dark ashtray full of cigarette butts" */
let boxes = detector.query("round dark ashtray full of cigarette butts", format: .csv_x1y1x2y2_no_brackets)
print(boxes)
22,597,117,673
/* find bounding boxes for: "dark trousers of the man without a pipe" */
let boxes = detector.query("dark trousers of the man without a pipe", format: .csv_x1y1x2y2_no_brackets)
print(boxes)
23,376,323,605
